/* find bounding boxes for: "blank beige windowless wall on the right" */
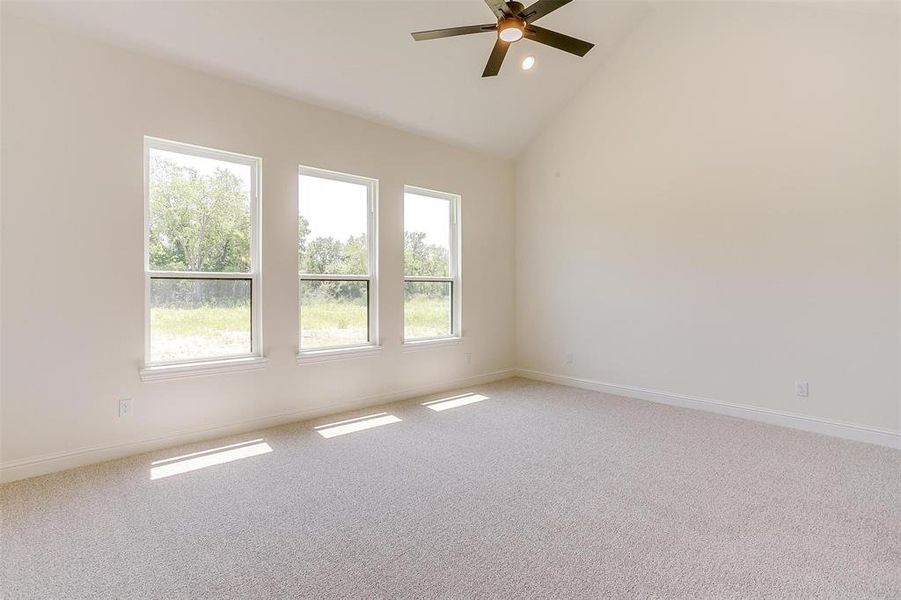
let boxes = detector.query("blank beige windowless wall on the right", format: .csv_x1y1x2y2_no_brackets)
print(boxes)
516,3,901,430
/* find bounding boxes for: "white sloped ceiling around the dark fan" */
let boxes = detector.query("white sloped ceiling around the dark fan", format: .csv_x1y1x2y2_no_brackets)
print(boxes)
4,0,649,157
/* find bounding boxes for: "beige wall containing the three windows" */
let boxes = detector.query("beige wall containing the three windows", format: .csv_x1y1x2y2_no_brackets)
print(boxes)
0,17,514,480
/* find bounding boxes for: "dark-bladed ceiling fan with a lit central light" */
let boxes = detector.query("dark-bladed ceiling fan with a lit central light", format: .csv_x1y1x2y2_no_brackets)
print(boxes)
411,0,594,77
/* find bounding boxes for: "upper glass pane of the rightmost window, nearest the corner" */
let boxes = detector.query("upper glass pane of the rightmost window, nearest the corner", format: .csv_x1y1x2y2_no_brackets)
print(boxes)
404,192,452,277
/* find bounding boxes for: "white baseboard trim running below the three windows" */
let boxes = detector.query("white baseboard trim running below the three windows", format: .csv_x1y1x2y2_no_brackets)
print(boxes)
0,369,514,483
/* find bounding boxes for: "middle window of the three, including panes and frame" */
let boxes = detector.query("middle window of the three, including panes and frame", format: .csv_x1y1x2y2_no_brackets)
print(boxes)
297,167,377,354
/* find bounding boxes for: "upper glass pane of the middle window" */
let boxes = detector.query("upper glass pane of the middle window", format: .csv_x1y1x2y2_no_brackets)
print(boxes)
297,175,369,275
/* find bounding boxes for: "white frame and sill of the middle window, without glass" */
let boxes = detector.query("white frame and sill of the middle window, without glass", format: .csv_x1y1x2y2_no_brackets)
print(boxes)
296,165,382,364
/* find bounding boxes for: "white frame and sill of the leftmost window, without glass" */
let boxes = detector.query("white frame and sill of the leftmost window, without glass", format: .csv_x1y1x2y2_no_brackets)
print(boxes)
141,136,267,381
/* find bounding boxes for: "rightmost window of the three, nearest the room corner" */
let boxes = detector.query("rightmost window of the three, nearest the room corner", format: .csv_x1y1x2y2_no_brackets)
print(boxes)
404,186,460,341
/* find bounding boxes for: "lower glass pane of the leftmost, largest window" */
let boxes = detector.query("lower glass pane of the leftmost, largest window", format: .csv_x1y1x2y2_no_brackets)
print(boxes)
150,279,251,362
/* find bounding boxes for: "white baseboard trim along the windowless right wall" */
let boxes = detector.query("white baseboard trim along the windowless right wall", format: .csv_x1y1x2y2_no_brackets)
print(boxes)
515,369,901,449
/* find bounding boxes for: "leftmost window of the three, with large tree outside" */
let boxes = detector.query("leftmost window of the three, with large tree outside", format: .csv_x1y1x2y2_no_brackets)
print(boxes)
144,138,260,366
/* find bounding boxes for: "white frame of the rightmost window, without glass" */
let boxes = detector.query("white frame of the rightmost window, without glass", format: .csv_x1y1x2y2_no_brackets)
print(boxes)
401,185,463,350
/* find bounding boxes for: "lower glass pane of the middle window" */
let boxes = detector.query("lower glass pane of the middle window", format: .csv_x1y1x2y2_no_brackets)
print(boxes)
300,281,369,350
